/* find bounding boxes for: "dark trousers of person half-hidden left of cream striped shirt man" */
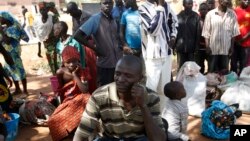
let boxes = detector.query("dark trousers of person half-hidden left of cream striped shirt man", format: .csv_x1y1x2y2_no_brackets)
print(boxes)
195,49,208,74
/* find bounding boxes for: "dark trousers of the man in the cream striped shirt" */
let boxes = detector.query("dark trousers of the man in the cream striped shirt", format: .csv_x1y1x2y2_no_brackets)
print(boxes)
208,55,229,72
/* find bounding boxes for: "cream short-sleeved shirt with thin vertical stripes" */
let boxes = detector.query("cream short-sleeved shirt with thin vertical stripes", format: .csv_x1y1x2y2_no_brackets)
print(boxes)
202,8,240,55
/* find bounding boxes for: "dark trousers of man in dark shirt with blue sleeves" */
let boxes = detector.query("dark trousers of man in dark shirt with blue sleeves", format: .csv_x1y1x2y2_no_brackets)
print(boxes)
97,67,115,87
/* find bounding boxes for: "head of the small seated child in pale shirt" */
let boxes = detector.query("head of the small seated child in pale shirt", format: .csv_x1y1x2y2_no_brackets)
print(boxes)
164,81,186,100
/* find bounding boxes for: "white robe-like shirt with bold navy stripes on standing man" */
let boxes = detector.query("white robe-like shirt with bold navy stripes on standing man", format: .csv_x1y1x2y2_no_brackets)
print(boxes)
138,1,178,59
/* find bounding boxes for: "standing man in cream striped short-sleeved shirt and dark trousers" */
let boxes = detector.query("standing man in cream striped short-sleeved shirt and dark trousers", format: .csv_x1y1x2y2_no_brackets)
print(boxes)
202,0,240,72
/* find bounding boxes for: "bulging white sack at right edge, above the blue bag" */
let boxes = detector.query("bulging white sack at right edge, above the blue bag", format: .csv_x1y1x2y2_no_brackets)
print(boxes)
221,67,250,113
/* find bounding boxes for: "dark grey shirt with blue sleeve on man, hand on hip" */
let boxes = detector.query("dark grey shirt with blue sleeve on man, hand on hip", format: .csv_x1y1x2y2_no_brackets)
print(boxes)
80,12,122,68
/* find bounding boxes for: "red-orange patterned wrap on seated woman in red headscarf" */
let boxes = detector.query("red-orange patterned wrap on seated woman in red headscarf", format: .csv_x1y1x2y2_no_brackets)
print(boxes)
48,81,90,141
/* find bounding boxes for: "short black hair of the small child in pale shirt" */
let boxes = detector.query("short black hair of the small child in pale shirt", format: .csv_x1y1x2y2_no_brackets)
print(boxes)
164,81,184,99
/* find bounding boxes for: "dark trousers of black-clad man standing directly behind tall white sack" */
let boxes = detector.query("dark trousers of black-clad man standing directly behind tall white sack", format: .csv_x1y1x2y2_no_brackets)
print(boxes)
177,52,194,70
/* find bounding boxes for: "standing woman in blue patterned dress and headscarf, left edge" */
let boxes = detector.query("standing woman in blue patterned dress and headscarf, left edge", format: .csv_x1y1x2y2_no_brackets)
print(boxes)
0,11,29,94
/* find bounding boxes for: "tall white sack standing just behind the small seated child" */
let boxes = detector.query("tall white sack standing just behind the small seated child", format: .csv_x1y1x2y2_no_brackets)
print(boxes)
176,61,207,117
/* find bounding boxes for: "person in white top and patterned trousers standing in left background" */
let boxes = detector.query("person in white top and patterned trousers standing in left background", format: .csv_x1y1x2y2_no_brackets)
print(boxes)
34,2,59,75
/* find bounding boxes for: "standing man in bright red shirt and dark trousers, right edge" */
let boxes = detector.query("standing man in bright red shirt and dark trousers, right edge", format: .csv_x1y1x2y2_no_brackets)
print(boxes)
231,0,250,74
